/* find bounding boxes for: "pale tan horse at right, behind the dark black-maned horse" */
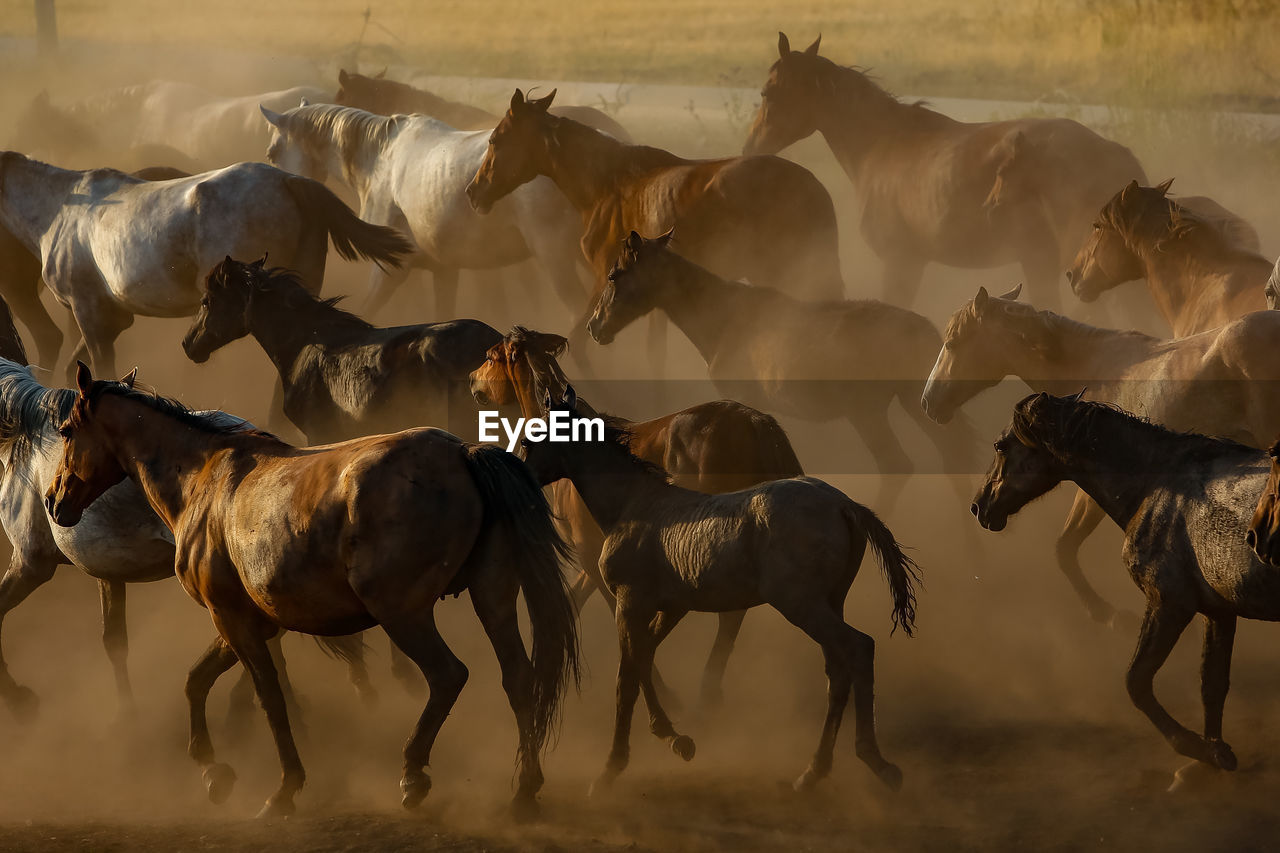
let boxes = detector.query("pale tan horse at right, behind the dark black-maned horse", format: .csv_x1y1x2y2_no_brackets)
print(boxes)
920,286,1280,628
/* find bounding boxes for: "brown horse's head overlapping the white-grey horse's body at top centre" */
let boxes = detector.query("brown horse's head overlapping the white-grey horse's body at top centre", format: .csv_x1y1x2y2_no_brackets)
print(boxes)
467,88,559,214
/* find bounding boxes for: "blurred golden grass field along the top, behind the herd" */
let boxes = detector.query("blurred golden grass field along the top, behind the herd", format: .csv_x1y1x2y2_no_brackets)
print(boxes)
0,0,1280,109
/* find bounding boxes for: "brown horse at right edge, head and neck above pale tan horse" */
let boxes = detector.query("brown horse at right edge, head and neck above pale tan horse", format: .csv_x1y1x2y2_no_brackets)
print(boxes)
1066,179,1272,338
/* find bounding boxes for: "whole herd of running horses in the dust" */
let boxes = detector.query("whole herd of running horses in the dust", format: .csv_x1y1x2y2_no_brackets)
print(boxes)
0,33,1280,817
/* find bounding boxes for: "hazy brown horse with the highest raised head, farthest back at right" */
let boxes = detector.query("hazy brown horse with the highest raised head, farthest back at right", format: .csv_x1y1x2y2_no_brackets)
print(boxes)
744,33,1146,311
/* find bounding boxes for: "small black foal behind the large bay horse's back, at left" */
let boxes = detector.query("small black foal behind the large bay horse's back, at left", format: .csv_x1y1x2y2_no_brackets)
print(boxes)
182,257,502,444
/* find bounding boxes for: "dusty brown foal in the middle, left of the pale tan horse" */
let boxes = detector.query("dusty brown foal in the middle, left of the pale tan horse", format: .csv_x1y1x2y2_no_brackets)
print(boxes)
588,225,977,512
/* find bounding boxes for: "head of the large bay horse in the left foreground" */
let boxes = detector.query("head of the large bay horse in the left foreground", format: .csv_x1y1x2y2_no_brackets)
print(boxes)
45,361,137,528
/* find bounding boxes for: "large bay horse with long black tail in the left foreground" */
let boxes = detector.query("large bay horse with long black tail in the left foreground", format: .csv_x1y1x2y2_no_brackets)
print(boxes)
46,364,579,817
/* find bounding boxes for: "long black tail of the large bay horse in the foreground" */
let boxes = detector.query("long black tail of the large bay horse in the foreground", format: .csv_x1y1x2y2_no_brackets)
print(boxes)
466,444,581,749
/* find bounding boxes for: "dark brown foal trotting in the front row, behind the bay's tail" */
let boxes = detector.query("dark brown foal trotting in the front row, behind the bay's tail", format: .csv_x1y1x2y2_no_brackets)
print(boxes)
525,387,919,790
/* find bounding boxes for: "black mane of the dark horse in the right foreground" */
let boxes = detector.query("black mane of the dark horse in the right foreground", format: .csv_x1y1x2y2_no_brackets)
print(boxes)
1012,394,1261,466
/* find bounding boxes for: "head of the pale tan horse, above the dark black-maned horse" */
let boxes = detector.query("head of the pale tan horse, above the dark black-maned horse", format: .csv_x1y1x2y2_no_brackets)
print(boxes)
920,284,1023,424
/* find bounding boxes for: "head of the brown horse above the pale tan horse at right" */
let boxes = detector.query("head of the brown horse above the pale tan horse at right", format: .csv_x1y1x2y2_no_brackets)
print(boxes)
1066,181,1171,302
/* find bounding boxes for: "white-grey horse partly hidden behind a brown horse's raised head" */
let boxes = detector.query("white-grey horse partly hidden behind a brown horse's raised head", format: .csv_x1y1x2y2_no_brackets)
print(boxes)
262,104,584,319
